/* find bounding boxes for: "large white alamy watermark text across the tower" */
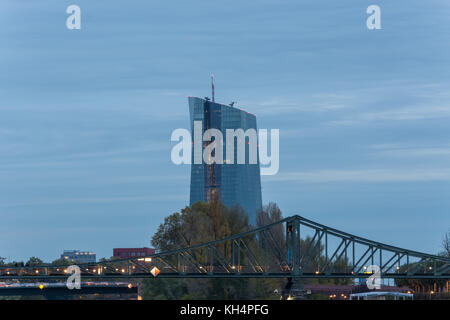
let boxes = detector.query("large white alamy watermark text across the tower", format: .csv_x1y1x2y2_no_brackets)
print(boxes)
171,121,280,175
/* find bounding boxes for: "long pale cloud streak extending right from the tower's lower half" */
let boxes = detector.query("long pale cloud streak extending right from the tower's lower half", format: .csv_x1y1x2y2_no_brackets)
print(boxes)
264,168,450,183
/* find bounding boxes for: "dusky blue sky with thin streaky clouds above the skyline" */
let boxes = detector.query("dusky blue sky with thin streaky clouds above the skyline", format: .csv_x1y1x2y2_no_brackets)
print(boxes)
0,0,450,261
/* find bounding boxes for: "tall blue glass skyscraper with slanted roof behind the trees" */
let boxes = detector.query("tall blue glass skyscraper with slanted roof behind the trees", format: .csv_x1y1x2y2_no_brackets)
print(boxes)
189,97,262,225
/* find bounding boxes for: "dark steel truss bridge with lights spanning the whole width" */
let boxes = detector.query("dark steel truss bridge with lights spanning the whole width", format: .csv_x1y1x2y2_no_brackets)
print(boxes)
0,215,450,281
